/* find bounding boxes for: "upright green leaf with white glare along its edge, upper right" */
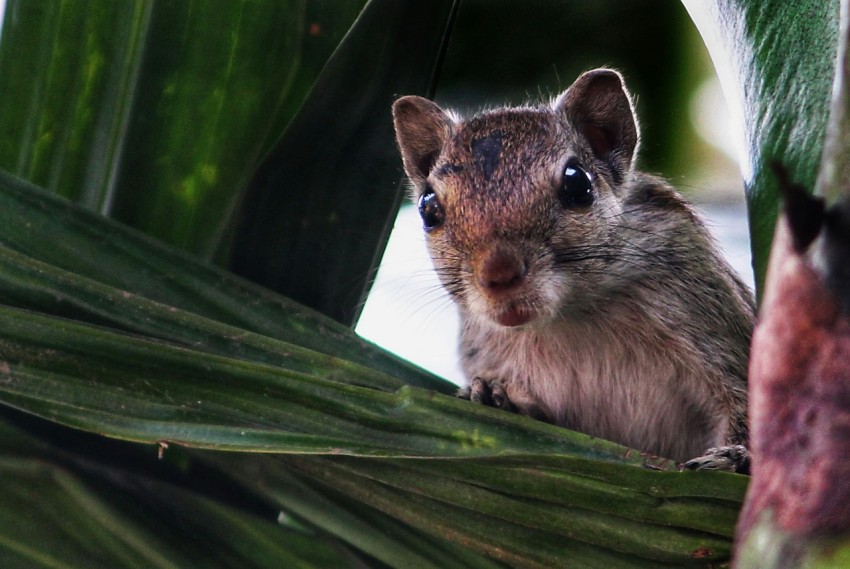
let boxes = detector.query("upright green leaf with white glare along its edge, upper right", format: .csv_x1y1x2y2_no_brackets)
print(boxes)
683,0,838,292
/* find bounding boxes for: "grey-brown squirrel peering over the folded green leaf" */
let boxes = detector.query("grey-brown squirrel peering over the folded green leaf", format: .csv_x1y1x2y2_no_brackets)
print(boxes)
393,69,755,472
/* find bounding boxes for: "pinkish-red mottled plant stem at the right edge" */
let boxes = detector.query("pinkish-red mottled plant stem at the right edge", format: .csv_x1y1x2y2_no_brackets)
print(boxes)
738,219,850,543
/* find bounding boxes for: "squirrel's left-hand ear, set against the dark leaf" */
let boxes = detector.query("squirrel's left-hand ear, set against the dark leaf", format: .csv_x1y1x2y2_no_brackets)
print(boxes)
393,96,454,184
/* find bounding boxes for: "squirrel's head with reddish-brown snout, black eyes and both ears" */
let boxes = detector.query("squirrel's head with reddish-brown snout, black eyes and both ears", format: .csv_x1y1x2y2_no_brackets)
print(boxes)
393,69,639,326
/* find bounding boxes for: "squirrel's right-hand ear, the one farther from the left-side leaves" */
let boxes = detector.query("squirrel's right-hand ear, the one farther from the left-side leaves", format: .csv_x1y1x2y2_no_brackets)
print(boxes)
554,69,640,176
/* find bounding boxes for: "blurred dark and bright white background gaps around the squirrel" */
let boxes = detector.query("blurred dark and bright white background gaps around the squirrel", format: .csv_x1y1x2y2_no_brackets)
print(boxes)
357,0,753,383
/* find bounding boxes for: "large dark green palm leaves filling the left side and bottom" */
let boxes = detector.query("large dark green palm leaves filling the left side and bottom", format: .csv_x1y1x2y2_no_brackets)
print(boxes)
0,0,830,567
